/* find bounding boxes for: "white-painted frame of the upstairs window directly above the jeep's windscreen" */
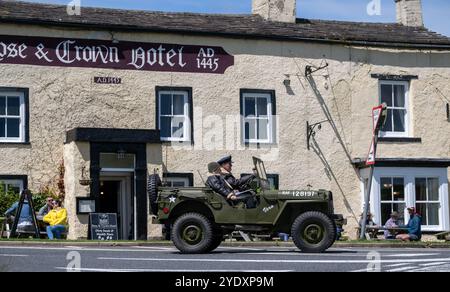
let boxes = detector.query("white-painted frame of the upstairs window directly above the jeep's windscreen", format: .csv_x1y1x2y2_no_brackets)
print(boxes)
241,92,273,144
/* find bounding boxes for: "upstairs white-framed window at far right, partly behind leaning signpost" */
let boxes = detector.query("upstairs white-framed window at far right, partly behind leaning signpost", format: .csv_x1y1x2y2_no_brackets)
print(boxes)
380,80,409,137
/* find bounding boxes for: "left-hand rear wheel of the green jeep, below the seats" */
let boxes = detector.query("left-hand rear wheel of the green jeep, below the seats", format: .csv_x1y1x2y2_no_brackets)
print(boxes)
172,213,214,254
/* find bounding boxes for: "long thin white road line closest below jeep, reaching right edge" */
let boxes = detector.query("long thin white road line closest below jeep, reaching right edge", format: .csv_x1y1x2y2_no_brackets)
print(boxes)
97,257,450,264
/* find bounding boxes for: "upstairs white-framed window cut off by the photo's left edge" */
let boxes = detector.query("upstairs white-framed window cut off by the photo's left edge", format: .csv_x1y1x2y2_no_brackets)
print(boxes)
0,91,25,143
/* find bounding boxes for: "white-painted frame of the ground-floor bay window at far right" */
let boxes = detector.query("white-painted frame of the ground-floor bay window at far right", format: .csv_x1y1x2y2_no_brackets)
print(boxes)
361,167,450,232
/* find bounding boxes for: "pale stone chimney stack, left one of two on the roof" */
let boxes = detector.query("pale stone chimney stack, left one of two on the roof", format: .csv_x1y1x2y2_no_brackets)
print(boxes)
252,0,297,23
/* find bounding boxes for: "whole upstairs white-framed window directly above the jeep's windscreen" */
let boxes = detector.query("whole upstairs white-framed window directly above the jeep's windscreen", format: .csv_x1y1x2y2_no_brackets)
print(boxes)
241,91,275,144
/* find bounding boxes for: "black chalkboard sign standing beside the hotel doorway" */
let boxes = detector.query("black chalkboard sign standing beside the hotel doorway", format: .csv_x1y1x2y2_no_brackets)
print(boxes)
90,213,119,240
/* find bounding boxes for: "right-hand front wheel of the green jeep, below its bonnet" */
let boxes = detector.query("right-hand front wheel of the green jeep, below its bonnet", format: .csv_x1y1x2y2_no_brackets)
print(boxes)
291,212,336,253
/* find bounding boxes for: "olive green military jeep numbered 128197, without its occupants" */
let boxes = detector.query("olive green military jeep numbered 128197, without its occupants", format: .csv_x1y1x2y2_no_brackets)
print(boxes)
148,157,342,253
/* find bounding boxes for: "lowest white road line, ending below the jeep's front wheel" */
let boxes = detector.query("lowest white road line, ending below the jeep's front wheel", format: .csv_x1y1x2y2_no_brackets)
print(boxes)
55,267,294,273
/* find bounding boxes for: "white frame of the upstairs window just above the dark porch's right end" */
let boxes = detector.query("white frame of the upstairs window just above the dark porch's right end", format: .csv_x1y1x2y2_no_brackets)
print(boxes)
158,90,191,142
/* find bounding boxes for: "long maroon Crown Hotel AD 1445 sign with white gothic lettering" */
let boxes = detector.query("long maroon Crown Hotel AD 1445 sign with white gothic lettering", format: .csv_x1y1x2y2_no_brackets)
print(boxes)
0,36,234,74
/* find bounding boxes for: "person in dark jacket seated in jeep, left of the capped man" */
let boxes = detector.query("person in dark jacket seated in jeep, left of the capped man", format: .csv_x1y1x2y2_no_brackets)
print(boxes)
206,162,256,208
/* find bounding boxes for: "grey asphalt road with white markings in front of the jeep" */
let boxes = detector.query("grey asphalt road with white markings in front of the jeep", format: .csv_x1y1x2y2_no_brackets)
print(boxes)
0,243,450,272
